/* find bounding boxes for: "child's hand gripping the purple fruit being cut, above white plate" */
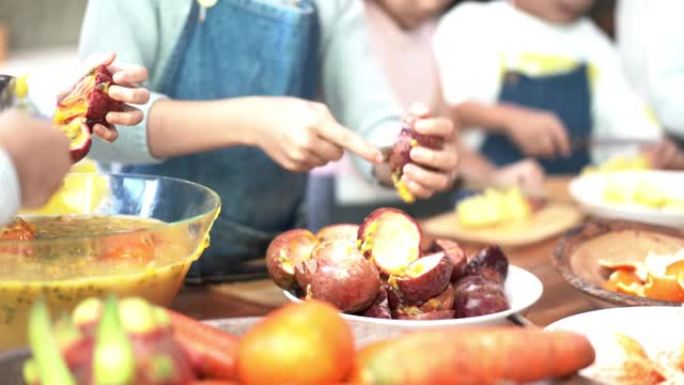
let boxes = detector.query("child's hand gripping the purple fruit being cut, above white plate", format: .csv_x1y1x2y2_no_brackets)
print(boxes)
402,106,458,199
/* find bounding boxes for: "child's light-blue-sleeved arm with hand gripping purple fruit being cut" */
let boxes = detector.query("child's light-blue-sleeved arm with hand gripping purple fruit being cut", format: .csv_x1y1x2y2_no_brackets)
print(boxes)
317,0,457,198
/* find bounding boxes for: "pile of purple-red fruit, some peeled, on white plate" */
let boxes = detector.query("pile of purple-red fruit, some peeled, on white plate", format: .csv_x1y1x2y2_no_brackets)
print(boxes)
266,208,509,320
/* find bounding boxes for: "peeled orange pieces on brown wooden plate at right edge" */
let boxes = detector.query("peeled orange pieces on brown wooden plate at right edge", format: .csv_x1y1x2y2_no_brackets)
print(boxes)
599,250,684,302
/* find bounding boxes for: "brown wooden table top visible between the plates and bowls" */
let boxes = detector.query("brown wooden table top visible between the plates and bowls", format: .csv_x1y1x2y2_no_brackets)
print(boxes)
172,178,593,326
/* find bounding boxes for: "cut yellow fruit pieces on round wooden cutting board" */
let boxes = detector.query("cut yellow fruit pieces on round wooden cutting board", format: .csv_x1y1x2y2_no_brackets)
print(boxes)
456,188,539,228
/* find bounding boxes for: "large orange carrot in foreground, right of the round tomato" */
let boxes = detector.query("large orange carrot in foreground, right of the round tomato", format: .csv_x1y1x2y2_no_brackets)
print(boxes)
352,327,594,385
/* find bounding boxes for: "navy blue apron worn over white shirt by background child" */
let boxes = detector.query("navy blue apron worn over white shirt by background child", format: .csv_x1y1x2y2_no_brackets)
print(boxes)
482,64,592,174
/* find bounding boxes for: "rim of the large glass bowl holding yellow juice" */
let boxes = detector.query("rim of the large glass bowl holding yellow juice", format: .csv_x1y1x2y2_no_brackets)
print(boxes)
0,172,221,245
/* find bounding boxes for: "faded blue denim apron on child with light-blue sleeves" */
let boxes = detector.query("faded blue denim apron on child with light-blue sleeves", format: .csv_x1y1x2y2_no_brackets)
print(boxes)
126,0,318,283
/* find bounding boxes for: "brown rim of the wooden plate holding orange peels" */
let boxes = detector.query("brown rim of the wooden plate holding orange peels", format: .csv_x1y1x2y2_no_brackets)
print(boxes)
551,219,684,306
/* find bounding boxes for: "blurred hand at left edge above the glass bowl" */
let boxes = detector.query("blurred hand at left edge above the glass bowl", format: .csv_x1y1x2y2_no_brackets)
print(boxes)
0,111,71,225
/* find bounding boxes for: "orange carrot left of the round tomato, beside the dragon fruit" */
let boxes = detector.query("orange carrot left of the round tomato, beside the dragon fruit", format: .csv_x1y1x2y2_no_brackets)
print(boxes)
167,310,239,380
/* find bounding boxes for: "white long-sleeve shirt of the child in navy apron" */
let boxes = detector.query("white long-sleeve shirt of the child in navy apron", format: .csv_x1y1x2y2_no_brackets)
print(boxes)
434,0,664,162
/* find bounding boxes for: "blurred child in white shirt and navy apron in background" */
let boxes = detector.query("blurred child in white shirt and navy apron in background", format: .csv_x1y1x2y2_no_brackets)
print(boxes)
434,0,680,174
